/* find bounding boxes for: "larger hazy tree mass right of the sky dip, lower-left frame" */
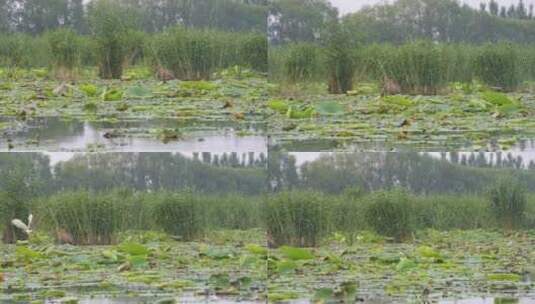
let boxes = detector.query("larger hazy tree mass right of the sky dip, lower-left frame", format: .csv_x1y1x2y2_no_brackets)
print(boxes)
55,153,266,193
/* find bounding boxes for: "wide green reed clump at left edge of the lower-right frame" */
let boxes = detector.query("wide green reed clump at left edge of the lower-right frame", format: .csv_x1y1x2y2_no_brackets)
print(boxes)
264,191,328,247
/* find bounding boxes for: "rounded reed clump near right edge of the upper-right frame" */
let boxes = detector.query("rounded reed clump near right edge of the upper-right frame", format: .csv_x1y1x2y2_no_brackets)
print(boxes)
473,43,520,91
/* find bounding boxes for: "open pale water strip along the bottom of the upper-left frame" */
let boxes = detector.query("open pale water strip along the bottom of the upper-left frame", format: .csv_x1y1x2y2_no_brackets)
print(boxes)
0,118,267,153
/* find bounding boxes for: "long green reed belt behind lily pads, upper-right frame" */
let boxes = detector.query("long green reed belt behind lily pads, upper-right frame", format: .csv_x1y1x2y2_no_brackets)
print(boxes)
269,41,535,95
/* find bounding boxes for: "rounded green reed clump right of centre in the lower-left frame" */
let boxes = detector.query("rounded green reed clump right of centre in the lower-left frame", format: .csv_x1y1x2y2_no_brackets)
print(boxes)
153,190,206,241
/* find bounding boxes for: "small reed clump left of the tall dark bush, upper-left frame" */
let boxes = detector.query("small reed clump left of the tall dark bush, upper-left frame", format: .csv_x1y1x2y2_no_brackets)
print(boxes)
46,28,82,79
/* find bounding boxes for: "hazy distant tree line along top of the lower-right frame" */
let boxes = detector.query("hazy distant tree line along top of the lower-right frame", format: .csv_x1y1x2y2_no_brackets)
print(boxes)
276,153,535,193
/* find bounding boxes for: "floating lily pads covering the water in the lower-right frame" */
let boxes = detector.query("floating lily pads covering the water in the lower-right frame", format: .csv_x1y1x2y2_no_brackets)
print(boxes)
268,230,534,303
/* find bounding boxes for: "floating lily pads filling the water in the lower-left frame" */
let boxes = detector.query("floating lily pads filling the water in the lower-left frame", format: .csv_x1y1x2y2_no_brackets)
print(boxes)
0,230,267,302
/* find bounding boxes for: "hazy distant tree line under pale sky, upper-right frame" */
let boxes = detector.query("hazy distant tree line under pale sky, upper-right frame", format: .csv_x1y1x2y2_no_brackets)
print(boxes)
268,0,535,45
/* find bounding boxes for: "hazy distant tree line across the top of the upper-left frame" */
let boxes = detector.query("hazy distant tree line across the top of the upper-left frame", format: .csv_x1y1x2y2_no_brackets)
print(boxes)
0,0,267,35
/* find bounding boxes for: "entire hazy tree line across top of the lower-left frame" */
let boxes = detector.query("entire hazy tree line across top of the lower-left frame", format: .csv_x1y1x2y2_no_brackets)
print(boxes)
0,153,267,194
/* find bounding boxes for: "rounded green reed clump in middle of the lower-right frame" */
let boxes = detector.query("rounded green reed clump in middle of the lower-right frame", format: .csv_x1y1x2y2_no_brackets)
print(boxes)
364,190,413,241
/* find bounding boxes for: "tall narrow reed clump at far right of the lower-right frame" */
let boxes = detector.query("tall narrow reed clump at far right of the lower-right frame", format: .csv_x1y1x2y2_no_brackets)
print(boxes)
489,177,527,230
